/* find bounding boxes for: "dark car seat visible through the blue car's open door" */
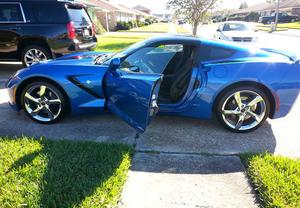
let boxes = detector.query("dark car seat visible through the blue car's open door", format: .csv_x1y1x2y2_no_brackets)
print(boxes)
158,45,195,104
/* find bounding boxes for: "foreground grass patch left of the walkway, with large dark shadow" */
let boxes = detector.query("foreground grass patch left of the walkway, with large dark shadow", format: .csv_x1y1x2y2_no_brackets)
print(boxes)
0,137,133,208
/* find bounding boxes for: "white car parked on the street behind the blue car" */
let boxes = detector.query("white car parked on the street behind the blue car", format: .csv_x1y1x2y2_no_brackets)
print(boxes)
214,21,258,43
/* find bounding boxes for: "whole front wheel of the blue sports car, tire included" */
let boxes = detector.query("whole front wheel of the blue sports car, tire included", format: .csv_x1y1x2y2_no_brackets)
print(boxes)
21,82,66,124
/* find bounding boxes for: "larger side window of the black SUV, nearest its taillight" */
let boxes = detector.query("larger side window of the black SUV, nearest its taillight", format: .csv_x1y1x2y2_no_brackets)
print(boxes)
23,2,68,24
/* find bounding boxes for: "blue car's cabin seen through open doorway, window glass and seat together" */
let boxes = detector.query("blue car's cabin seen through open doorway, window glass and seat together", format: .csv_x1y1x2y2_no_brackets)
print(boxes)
116,44,196,104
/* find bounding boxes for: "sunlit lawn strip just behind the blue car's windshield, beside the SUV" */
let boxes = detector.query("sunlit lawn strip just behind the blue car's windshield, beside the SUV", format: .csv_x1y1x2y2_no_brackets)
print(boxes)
95,32,151,52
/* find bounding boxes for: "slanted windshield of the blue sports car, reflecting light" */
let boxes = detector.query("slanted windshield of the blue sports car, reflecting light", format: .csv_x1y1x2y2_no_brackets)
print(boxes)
94,40,147,65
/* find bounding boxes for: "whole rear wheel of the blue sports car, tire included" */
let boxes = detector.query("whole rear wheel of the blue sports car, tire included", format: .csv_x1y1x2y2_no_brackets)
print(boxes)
216,87,270,133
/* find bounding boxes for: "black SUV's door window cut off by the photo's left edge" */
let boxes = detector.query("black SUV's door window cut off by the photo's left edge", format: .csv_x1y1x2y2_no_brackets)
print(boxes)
0,3,24,23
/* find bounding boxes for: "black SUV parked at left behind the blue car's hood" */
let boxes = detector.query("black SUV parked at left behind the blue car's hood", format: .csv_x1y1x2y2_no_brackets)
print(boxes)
0,0,97,66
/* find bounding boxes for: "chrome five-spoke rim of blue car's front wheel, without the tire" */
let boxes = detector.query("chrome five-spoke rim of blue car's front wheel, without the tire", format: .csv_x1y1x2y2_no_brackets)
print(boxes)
24,85,62,123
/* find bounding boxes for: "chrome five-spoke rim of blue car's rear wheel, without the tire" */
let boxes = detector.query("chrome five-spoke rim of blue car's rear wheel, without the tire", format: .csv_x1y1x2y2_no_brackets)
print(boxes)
222,90,267,131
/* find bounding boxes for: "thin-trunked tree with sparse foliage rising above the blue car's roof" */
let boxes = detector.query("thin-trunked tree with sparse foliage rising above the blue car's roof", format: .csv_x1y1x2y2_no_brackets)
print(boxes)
167,0,218,35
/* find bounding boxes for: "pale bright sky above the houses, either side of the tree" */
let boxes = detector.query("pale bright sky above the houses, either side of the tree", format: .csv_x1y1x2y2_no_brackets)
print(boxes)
110,0,266,13
